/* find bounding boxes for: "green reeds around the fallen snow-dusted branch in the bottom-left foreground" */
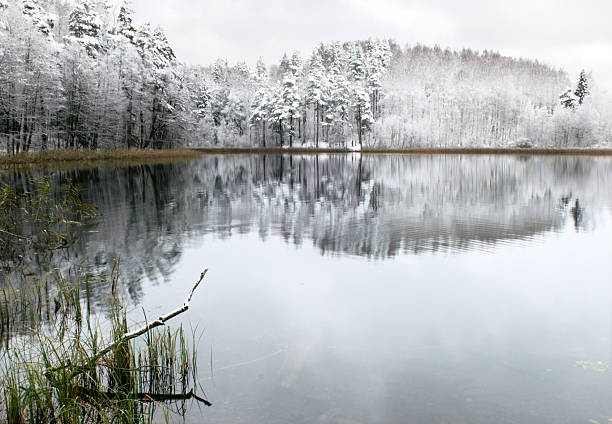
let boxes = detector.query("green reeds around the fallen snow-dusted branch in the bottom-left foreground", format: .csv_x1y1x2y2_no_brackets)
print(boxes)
0,266,210,423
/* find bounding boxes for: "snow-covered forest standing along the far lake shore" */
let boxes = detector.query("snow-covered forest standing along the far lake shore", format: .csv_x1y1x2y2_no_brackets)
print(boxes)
0,0,612,153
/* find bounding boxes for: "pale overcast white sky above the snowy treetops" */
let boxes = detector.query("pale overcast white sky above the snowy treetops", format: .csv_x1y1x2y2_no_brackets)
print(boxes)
133,0,612,92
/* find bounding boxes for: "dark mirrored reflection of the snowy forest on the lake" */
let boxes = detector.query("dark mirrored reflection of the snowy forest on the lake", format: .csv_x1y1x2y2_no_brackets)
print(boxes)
3,155,612,298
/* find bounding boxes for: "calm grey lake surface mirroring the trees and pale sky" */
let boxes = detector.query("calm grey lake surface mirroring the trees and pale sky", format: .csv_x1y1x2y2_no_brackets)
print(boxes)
13,155,612,423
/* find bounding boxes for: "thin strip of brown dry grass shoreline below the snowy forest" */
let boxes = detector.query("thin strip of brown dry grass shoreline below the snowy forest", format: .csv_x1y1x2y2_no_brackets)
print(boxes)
0,147,612,166
